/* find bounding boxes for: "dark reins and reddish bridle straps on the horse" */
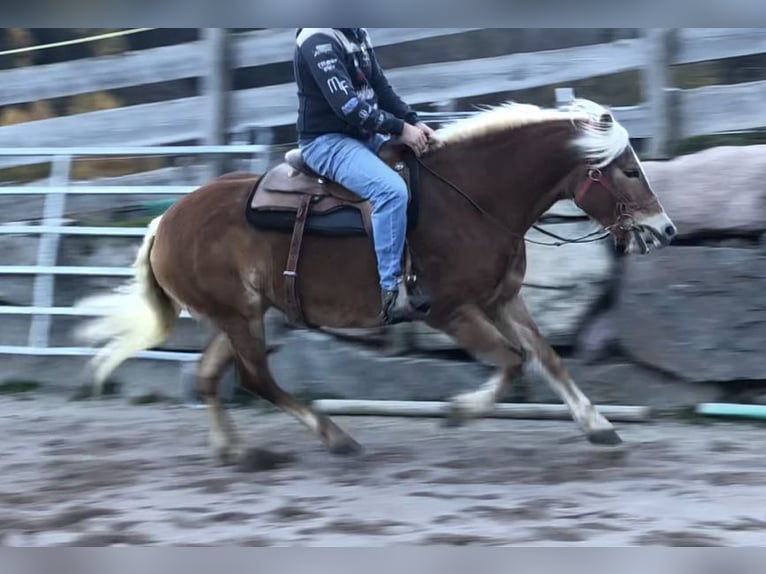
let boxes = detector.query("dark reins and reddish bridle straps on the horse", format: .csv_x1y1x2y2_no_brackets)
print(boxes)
415,156,638,247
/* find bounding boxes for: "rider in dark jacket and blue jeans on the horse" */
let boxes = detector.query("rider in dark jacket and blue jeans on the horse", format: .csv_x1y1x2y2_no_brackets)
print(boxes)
293,28,434,324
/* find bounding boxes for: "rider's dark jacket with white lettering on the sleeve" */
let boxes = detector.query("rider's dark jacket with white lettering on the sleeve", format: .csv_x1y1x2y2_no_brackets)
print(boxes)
293,28,419,140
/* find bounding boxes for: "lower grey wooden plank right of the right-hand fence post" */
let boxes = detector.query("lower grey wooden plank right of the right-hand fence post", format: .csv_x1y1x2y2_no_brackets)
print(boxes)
680,80,766,137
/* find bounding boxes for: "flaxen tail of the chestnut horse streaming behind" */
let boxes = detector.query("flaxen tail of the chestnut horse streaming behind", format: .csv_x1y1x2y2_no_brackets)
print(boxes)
75,216,181,394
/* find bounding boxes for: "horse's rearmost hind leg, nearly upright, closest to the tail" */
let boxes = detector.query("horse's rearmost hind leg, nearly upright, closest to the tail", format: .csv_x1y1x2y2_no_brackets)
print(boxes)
197,333,241,464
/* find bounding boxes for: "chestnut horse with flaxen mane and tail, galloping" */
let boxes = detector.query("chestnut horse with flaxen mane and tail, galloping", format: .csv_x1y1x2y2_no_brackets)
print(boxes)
78,99,676,464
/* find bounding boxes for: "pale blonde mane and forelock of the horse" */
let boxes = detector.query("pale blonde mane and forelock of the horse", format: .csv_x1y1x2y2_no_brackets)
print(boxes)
432,98,630,167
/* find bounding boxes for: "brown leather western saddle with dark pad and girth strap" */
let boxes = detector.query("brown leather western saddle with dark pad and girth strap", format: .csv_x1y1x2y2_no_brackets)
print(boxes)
246,143,424,325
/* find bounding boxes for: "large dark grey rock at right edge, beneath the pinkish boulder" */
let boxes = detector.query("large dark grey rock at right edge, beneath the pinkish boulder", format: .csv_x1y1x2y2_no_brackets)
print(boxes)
616,247,766,381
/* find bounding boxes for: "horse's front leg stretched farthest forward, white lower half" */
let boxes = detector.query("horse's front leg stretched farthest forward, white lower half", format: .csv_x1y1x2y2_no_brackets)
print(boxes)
495,296,622,445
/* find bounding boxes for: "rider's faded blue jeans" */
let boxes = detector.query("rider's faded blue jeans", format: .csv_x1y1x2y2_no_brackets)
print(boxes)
299,133,407,290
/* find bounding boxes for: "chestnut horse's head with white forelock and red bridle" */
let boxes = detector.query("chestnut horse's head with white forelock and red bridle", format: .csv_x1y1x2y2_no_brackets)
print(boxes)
568,100,676,253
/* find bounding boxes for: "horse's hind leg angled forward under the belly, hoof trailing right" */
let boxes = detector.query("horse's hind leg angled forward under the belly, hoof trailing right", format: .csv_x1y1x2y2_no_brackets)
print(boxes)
226,311,361,460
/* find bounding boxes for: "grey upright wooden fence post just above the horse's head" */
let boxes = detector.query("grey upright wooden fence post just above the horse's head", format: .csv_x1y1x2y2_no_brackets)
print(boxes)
642,28,678,159
